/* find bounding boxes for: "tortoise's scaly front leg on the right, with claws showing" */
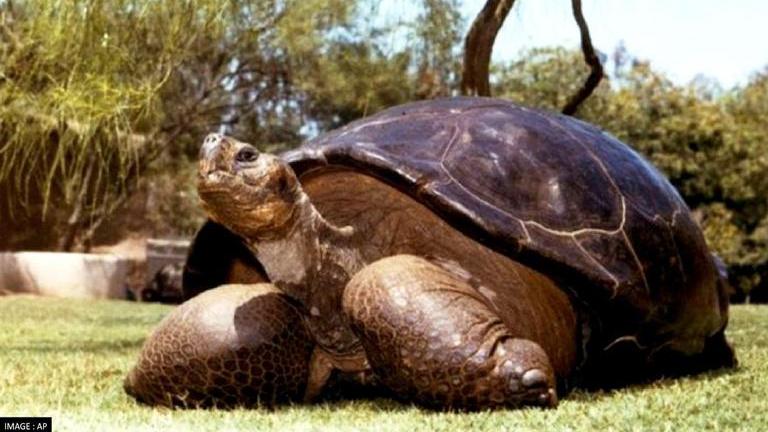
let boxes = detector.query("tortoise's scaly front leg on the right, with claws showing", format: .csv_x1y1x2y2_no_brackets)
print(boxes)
343,255,557,409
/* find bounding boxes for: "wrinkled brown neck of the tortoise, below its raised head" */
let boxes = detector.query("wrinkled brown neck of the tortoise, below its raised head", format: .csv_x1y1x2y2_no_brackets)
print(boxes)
249,190,365,356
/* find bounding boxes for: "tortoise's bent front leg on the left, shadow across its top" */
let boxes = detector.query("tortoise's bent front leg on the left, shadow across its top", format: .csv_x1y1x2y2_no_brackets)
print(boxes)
124,283,314,408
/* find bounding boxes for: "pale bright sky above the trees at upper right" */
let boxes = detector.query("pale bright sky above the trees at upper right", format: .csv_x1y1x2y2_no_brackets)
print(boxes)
382,0,768,88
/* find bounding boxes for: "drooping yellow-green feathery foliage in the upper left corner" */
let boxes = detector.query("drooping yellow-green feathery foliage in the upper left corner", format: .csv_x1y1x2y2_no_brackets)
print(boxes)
0,0,258,243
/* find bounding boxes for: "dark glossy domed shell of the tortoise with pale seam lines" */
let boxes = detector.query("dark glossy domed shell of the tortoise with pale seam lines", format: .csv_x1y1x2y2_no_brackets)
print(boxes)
282,98,727,352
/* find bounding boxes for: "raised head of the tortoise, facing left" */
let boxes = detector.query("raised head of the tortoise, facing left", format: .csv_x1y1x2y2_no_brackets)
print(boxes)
198,134,303,240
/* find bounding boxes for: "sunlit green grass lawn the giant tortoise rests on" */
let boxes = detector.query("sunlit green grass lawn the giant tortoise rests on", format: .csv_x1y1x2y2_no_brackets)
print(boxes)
0,296,768,432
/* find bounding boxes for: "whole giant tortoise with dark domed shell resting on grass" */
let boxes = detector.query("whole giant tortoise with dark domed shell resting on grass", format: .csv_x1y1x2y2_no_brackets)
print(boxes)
126,98,736,410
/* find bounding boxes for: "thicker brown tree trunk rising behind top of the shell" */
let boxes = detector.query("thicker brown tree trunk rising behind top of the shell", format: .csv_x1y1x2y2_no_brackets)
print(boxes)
461,0,515,96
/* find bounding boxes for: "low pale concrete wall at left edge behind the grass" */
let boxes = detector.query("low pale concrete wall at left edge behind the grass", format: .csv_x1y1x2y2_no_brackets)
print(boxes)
0,252,130,298
